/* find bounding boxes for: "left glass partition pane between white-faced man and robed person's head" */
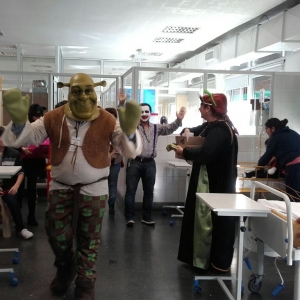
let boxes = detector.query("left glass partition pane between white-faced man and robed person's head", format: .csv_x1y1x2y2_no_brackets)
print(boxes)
139,69,203,131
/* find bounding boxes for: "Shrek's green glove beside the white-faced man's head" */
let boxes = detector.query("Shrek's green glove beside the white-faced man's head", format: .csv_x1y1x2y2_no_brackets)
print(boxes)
118,100,141,135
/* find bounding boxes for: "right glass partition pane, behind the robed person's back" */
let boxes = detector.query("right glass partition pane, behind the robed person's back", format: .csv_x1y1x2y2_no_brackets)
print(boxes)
208,73,272,135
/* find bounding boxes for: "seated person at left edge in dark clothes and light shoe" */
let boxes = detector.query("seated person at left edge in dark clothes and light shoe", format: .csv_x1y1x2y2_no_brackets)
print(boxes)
0,126,33,240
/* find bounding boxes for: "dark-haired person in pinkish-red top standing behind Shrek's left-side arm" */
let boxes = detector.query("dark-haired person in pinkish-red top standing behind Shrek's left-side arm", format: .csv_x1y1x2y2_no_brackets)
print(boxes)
21,104,49,226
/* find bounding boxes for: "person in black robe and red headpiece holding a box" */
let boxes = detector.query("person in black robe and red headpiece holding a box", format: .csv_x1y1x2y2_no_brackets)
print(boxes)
175,90,238,273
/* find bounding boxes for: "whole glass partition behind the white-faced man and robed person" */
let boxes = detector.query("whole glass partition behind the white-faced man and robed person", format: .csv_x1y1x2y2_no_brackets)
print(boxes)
123,67,273,135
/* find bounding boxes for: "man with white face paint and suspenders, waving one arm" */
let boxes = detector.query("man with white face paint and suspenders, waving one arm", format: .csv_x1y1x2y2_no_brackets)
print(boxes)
120,101,185,227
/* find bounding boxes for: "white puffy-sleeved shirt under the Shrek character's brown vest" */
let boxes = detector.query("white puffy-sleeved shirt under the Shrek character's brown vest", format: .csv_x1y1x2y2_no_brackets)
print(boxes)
2,117,142,196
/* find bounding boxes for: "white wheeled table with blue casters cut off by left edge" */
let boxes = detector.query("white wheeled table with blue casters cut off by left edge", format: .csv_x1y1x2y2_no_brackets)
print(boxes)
0,166,21,286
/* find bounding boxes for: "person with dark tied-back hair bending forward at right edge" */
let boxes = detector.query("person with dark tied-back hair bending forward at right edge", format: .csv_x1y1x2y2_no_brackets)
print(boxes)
258,118,300,202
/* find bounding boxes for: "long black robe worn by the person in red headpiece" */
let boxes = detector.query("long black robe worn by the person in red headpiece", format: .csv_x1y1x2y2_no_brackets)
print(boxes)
178,121,238,272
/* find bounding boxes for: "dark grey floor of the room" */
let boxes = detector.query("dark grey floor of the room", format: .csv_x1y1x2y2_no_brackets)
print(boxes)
0,200,293,300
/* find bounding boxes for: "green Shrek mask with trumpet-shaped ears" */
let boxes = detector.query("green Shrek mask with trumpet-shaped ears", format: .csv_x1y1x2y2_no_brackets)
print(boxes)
57,73,106,121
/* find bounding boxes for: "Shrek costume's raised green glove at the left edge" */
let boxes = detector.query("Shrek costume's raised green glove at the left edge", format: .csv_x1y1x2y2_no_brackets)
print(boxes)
3,89,30,125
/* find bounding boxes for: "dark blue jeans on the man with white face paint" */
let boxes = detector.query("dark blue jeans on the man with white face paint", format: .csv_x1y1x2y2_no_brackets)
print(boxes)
125,159,156,221
